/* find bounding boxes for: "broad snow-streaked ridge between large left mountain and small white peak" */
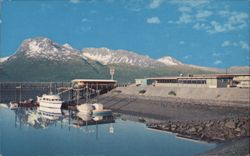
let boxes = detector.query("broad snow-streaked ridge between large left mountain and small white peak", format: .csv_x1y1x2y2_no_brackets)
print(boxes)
82,48,165,67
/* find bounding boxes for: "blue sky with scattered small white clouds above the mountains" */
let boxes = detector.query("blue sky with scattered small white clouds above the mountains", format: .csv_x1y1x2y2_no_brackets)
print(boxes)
0,0,250,68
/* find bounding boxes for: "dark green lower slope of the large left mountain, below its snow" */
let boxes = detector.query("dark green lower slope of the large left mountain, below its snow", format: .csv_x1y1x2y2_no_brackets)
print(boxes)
0,57,109,81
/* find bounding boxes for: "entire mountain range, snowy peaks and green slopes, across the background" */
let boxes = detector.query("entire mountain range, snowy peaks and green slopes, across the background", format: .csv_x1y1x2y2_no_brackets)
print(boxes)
0,37,246,83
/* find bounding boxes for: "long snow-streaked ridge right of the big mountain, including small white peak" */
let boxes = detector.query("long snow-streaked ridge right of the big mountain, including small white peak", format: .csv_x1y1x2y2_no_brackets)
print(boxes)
82,48,224,73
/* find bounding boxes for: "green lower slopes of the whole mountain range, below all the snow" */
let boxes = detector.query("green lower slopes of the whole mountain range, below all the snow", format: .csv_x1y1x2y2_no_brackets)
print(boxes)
0,57,217,83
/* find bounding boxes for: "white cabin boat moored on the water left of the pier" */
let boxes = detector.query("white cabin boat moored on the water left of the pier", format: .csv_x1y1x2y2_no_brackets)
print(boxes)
37,94,63,109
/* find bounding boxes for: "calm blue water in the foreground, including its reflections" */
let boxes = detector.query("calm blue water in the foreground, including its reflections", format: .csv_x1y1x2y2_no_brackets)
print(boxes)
0,87,215,156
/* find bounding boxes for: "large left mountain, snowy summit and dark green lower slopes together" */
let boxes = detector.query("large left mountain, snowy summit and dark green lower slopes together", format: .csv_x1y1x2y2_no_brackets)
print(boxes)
0,38,109,81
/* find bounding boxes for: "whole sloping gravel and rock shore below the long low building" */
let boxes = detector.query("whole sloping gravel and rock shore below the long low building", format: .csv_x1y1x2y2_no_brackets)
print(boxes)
96,87,250,155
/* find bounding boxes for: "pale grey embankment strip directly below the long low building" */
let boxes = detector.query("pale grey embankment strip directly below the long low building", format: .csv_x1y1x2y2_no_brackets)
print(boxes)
116,86,250,103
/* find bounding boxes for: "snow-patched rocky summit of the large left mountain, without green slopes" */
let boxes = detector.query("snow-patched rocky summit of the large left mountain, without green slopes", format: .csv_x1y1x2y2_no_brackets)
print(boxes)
11,37,81,61
